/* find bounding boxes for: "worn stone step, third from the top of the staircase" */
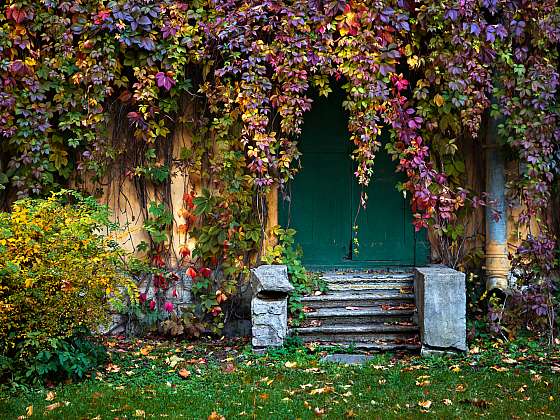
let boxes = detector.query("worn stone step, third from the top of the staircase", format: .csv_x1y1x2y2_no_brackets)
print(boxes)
301,290,414,309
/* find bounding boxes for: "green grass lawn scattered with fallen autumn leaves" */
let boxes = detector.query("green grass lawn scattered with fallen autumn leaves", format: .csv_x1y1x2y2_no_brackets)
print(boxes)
0,341,560,420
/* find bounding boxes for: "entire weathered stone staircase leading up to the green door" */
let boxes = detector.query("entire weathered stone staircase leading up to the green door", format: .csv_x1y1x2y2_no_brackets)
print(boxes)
292,272,420,351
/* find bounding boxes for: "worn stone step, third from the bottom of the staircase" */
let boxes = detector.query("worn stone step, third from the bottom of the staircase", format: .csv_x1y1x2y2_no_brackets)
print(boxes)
302,305,414,327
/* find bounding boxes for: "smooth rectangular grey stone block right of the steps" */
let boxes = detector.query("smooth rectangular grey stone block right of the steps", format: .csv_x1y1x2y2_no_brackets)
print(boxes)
414,265,467,356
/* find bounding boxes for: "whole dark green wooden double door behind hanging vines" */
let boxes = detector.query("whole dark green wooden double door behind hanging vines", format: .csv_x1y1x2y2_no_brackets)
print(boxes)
279,92,427,269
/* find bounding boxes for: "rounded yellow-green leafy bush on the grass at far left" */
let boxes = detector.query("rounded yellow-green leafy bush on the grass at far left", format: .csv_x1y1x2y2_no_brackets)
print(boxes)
0,190,136,384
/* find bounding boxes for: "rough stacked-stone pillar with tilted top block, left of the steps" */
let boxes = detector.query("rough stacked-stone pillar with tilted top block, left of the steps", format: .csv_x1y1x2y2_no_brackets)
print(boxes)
251,265,294,350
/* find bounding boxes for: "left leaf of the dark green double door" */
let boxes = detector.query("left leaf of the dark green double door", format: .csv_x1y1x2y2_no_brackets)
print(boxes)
280,90,352,265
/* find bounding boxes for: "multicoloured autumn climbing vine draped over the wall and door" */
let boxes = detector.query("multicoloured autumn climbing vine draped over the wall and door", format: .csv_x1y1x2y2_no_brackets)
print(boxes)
0,0,560,328
